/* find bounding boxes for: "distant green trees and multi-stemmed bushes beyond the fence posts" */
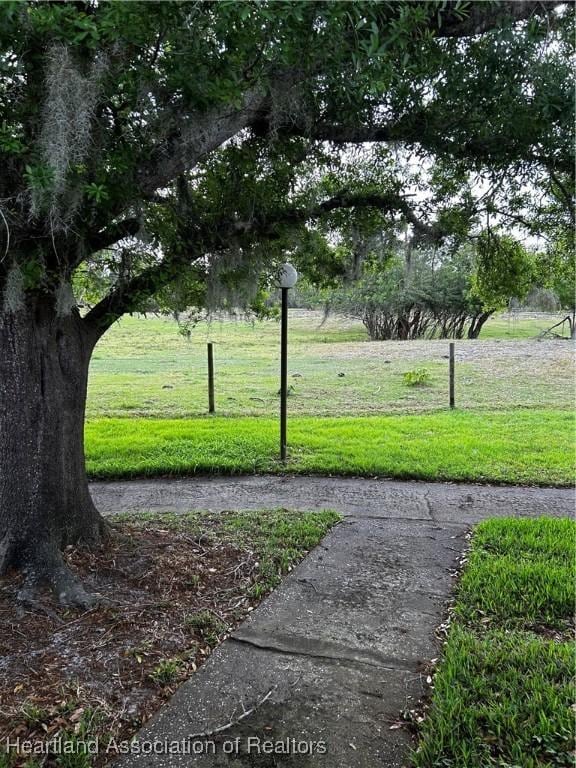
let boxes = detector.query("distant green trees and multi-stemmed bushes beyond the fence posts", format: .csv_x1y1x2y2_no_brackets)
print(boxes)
295,232,574,341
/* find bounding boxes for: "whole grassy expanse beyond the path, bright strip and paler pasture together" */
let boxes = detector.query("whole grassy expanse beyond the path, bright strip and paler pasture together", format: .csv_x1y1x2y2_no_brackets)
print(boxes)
86,310,574,485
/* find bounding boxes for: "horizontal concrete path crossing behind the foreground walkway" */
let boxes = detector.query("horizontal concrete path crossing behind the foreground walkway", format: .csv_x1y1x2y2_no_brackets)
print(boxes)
91,475,575,523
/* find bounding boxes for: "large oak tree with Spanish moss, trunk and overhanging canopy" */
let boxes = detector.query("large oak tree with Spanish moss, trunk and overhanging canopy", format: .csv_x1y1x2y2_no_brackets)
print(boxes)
0,0,572,604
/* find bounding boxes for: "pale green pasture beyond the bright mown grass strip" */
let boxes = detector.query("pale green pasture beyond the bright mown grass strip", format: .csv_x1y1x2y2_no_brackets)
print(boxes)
88,312,574,418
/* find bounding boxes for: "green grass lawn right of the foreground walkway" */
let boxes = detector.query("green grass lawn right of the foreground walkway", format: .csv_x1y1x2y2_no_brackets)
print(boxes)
413,518,576,768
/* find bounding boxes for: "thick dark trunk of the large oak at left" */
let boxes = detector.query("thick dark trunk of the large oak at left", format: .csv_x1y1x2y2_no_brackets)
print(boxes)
0,300,106,605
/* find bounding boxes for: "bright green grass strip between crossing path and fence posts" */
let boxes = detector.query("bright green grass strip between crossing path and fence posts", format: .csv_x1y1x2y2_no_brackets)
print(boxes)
86,410,574,485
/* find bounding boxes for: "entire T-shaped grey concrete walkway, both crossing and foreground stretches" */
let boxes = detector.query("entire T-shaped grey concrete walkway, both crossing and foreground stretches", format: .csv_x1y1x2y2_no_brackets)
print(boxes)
92,477,574,768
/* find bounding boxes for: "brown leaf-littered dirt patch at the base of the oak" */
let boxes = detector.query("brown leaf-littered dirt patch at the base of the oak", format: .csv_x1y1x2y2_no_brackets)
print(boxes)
0,513,338,765
